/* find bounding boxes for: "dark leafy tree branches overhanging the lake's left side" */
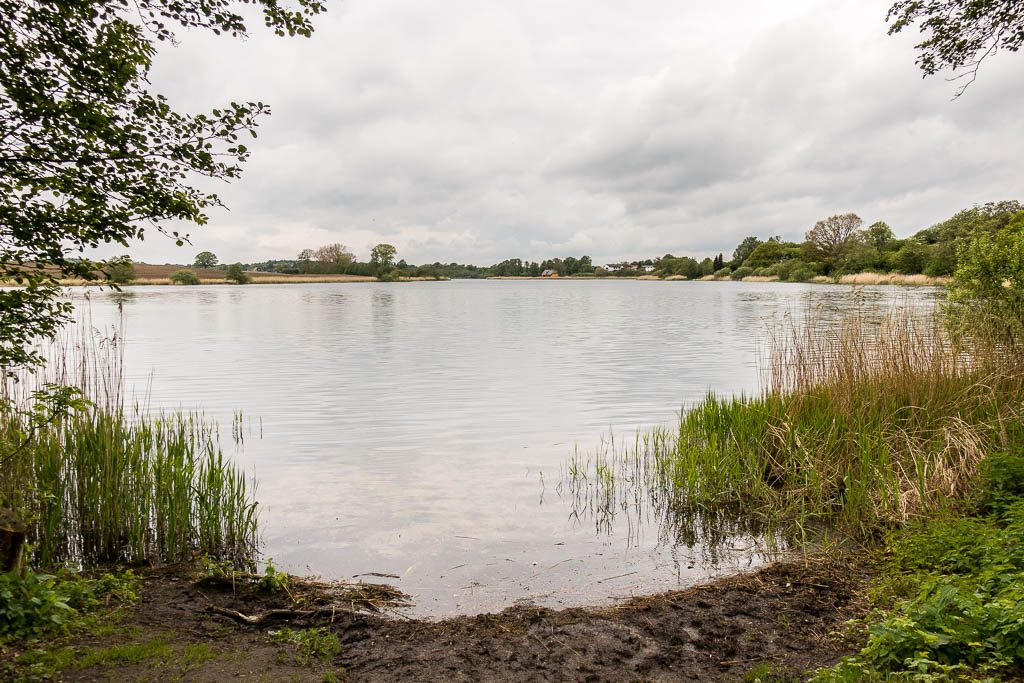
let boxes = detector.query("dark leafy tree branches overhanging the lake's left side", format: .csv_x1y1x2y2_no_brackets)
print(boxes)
0,0,324,367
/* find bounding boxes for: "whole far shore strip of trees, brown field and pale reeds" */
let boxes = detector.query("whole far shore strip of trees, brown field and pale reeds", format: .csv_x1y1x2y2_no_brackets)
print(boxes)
8,201,1011,287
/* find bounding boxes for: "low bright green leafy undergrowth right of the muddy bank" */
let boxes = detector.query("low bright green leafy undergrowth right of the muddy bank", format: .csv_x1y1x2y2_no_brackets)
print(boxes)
815,455,1024,681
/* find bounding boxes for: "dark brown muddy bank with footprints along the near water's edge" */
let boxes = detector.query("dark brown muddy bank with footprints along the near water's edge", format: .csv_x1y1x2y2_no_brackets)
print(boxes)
0,561,867,681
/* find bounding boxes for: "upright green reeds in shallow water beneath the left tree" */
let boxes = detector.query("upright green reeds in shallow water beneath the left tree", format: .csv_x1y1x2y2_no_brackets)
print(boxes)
0,313,258,568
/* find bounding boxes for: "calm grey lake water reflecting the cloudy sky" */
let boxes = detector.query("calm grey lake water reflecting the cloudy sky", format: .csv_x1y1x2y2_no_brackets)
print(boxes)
73,280,932,616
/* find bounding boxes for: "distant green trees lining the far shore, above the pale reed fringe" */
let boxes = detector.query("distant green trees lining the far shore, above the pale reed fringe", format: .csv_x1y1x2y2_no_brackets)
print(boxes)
174,201,1024,282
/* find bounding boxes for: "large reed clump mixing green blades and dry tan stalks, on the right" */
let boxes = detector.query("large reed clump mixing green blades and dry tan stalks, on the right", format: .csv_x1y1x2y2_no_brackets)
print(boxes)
563,306,1024,538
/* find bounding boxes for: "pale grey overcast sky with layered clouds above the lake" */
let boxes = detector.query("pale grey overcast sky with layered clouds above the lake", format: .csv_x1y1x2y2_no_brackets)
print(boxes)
112,0,1024,265
